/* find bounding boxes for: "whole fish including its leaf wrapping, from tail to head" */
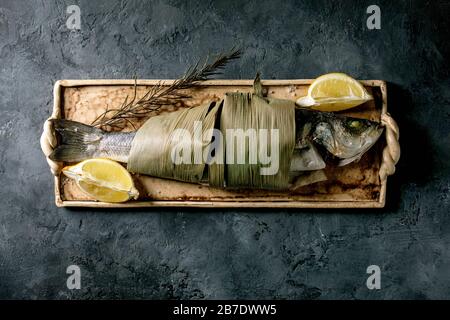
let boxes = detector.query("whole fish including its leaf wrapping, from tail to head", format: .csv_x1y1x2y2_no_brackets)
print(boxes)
50,82,383,189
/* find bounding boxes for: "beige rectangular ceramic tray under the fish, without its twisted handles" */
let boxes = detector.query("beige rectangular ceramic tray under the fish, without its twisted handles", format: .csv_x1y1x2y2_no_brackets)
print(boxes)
48,80,387,208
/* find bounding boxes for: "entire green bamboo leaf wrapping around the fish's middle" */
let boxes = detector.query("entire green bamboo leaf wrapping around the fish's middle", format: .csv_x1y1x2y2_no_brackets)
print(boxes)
128,79,295,189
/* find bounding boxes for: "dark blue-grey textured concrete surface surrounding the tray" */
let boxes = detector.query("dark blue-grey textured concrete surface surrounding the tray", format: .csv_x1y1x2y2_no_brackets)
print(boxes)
0,0,450,299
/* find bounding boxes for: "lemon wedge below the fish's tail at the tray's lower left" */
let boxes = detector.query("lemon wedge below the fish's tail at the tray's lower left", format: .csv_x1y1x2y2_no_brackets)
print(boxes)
62,159,139,202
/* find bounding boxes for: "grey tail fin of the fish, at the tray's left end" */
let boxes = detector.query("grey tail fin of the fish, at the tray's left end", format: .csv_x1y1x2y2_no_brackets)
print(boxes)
49,119,103,162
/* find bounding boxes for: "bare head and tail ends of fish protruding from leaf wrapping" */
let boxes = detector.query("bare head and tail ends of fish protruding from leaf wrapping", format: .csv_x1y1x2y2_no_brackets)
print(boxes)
50,108,383,184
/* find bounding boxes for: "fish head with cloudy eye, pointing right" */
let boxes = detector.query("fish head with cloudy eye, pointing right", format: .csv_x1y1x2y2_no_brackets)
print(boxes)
312,115,383,161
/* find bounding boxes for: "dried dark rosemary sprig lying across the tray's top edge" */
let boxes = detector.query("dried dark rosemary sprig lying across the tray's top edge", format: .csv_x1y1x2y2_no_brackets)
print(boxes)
91,49,241,131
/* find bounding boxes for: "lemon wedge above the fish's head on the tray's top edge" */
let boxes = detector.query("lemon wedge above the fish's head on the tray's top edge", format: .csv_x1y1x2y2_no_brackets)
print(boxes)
296,73,373,112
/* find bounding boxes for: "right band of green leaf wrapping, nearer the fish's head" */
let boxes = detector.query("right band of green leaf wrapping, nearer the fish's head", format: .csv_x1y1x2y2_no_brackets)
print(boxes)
220,93,295,189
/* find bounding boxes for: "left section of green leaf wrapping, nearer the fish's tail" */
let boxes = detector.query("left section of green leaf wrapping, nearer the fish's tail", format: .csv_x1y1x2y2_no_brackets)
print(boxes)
127,102,220,182
